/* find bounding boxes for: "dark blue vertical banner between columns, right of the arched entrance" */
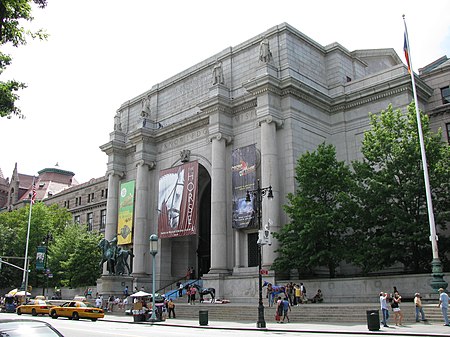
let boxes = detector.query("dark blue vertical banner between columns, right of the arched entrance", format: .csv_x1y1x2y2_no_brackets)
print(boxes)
231,144,256,229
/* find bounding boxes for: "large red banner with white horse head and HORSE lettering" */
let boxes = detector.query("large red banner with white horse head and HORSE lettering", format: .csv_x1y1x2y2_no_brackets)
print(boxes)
158,161,198,238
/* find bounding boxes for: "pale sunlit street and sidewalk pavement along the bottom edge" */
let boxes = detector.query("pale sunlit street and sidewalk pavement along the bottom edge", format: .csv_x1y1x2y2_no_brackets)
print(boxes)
0,313,450,337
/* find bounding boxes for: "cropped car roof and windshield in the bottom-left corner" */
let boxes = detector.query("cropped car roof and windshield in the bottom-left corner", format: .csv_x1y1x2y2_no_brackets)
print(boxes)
0,319,64,337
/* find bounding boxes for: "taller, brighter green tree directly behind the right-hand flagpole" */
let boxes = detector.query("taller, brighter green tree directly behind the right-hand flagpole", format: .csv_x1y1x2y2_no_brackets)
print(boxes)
351,104,450,273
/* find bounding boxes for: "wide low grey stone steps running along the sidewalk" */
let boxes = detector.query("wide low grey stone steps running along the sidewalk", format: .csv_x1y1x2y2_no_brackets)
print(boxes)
170,298,443,324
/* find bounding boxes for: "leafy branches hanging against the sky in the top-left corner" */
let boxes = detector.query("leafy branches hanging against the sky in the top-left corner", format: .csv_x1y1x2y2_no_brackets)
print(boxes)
0,0,47,118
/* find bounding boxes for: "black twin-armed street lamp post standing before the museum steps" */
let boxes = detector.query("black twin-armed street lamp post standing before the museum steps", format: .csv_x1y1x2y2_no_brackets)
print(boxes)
245,179,273,328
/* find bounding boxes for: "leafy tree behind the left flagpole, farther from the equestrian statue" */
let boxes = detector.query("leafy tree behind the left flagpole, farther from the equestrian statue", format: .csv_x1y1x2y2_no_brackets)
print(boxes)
0,202,72,287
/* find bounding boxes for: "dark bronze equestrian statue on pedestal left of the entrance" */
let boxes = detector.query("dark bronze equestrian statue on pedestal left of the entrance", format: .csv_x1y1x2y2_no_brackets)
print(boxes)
98,237,134,275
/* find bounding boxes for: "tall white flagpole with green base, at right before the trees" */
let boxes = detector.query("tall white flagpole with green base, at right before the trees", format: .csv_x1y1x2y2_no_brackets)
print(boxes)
403,14,448,292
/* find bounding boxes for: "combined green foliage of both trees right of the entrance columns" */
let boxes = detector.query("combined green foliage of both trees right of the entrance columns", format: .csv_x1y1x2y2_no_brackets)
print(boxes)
273,104,450,277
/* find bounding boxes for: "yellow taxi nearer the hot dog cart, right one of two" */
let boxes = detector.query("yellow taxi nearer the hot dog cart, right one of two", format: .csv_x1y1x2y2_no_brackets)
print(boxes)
48,301,105,322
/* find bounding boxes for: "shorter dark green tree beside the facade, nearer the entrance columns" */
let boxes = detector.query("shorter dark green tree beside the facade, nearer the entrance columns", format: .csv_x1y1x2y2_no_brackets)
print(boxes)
272,144,352,277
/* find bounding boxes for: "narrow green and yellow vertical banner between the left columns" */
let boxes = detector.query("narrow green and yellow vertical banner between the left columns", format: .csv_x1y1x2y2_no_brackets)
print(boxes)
117,180,136,245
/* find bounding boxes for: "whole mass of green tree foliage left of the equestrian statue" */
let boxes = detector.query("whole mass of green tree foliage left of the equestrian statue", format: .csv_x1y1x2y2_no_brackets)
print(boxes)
0,202,101,288
